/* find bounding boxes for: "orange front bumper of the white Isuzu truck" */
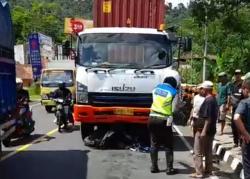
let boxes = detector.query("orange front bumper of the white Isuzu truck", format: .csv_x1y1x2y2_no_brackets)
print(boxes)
74,104,150,124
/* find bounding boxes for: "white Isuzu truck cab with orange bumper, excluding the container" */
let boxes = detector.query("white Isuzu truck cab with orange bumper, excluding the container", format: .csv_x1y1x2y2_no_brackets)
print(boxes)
74,27,180,136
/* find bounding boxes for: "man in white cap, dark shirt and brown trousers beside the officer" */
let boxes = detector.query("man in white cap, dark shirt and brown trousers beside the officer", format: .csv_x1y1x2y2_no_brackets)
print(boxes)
191,81,218,178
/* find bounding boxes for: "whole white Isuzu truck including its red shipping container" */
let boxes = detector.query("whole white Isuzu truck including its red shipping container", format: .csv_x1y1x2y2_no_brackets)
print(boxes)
74,0,189,138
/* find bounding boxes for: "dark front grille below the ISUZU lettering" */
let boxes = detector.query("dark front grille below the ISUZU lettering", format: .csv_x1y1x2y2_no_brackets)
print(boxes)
88,93,152,107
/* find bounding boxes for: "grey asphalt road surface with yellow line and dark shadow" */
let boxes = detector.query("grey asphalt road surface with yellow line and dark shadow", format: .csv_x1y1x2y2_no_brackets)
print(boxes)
0,104,238,179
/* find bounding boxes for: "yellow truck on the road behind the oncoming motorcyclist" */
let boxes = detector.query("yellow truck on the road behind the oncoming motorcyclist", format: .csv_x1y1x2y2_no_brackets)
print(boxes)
40,62,75,112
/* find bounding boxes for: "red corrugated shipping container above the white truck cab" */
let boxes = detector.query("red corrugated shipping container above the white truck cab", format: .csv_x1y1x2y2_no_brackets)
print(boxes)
93,0,166,29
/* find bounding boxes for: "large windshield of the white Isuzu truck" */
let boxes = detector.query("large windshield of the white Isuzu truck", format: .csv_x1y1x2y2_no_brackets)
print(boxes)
78,33,172,68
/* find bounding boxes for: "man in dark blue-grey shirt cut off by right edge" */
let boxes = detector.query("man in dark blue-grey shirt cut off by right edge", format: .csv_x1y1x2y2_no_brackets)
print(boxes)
234,79,250,179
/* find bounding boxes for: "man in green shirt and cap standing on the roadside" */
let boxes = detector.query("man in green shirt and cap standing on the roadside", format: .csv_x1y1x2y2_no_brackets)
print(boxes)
217,72,230,135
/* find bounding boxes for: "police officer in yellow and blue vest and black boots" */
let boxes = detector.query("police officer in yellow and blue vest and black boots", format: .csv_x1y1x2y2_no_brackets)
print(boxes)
148,77,178,175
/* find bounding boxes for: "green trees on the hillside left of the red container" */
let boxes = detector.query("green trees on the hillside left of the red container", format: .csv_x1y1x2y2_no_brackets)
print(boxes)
10,0,92,44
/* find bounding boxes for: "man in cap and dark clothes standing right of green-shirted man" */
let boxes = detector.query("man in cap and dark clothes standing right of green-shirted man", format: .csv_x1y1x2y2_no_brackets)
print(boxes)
229,69,243,147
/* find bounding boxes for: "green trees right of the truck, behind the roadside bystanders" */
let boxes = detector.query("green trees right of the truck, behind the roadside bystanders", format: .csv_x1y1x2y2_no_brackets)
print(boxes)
167,0,250,83
